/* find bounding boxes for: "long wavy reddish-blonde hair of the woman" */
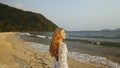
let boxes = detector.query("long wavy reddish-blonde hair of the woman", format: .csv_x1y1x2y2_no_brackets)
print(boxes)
49,27,64,57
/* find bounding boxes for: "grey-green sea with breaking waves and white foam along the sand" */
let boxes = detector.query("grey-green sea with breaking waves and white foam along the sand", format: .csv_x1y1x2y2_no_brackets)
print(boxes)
16,31,120,68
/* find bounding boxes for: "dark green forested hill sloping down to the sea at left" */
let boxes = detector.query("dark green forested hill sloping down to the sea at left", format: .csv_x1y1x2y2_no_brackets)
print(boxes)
0,3,58,32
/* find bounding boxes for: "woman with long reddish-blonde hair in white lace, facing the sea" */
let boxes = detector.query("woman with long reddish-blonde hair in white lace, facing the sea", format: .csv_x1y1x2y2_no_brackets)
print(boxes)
49,28,68,68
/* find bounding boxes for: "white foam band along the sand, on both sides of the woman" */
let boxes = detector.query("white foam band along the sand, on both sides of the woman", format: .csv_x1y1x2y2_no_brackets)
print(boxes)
26,42,120,68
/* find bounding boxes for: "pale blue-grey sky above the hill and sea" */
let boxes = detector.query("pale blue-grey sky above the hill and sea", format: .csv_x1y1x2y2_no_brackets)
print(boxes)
0,0,120,31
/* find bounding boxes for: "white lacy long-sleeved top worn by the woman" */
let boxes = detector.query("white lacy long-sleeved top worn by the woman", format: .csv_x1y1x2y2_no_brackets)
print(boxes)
53,42,68,68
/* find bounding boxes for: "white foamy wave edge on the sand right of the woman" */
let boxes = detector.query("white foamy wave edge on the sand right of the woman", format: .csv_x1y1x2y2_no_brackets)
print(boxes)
68,52,120,68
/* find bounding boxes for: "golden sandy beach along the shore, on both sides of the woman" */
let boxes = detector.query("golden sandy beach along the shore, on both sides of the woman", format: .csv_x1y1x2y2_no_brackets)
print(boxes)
0,32,108,68
